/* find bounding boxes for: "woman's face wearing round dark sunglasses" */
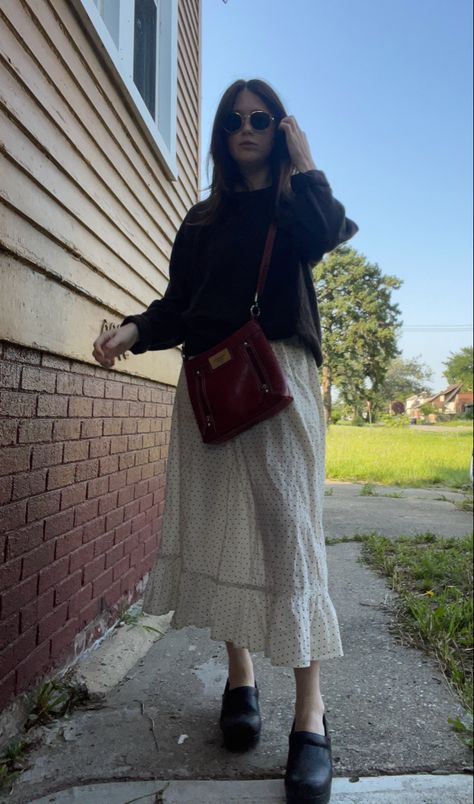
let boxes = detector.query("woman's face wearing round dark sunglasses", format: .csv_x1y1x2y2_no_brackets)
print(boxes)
226,89,275,172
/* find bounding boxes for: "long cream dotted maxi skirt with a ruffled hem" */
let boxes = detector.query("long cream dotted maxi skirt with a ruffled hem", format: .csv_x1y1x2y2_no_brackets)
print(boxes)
143,336,343,667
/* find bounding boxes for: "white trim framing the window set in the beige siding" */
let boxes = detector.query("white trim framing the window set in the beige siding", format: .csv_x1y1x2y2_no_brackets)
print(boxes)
74,0,178,181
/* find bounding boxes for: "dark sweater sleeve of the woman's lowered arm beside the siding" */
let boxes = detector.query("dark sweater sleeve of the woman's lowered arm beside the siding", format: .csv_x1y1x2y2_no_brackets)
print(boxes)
121,216,191,355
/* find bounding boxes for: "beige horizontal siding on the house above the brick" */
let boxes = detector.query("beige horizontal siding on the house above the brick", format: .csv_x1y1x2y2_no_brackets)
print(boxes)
0,0,200,383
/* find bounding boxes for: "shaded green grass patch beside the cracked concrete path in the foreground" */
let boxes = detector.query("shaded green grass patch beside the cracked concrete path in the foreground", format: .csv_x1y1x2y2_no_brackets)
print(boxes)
361,533,473,742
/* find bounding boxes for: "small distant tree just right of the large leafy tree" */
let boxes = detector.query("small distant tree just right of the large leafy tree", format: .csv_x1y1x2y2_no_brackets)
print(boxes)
374,355,433,411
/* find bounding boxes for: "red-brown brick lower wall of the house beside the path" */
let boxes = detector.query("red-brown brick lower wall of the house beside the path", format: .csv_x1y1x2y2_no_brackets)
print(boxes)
0,343,174,711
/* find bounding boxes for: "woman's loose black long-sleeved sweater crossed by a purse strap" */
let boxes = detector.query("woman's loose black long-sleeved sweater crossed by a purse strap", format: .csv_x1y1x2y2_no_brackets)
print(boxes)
122,170,358,366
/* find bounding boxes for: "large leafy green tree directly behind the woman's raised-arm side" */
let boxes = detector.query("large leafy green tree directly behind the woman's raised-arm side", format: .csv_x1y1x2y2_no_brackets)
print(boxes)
313,245,402,425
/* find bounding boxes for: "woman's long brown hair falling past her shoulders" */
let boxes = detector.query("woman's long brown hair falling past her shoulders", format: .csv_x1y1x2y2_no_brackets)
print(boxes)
191,78,294,225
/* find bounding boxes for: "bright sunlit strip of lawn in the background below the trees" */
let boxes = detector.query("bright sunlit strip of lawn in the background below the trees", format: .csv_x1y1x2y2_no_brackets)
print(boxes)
326,425,472,488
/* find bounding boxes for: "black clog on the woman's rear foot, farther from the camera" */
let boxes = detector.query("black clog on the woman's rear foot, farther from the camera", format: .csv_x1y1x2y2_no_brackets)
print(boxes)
219,679,262,751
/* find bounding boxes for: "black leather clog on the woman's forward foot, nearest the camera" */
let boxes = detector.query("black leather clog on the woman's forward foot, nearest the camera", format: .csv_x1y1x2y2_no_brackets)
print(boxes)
285,715,332,804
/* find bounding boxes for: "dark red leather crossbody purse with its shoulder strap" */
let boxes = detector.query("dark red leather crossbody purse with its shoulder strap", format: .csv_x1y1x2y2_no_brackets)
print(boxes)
184,222,293,444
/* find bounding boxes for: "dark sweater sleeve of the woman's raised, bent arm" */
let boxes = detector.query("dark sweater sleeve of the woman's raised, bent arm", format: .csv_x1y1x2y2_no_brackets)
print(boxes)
291,170,359,262
